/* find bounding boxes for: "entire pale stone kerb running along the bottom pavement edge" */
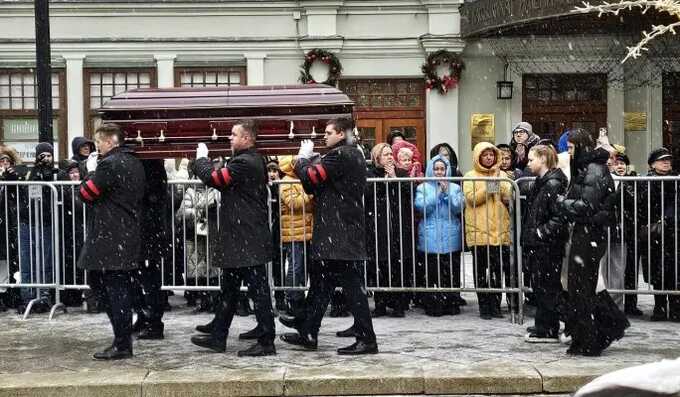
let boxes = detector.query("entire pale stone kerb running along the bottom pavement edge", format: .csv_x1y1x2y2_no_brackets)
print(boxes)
0,359,638,397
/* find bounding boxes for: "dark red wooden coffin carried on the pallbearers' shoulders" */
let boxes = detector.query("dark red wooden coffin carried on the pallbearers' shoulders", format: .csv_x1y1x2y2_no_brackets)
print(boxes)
99,84,353,159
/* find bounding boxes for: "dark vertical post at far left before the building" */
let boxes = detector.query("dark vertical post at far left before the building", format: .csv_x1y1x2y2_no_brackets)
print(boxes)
35,0,54,143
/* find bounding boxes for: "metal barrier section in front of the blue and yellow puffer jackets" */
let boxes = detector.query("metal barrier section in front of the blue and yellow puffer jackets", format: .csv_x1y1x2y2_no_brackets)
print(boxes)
270,177,523,321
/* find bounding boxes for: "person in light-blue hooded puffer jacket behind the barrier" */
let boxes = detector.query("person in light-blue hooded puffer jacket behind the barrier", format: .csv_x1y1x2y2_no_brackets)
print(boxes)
415,155,464,316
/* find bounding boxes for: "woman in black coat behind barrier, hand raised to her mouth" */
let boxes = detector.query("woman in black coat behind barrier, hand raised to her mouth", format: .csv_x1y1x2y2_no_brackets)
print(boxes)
364,143,413,317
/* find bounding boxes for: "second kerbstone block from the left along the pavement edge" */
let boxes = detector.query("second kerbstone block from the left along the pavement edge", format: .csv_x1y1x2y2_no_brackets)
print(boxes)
142,368,286,397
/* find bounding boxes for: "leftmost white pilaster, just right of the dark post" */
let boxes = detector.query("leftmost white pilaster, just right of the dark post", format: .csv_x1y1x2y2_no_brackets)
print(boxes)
64,54,85,152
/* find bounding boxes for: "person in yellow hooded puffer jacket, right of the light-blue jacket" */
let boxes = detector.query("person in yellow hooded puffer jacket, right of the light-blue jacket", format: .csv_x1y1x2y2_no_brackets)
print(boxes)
463,142,512,320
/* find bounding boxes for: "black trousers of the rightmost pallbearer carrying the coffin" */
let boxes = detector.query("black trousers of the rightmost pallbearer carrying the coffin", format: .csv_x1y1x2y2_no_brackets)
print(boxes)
303,261,375,343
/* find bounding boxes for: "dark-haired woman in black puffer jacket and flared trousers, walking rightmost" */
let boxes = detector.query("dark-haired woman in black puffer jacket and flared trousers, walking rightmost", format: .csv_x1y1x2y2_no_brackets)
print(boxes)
559,129,629,356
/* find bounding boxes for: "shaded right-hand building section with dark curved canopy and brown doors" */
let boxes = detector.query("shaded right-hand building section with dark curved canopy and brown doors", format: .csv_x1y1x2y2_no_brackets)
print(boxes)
459,0,680,173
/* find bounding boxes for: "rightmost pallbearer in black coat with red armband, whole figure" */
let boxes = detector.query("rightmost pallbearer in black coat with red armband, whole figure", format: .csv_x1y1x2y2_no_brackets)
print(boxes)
281,119,378,355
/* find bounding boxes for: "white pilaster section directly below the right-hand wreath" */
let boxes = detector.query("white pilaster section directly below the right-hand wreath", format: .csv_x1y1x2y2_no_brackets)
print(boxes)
427,88,461,158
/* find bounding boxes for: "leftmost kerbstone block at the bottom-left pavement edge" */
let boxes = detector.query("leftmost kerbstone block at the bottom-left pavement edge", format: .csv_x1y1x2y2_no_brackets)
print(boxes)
0,369,149,397
